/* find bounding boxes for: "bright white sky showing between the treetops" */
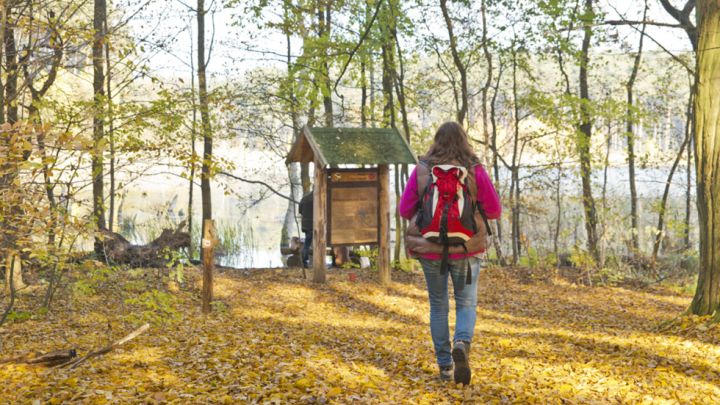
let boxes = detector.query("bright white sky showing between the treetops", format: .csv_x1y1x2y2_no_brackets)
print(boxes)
122,0,690,86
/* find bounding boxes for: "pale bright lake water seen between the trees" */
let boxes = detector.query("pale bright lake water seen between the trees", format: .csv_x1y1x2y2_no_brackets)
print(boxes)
111,159,694,268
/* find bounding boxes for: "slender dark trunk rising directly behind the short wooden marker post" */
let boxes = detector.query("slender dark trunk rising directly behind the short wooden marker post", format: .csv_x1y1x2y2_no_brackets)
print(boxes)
197,0,213,252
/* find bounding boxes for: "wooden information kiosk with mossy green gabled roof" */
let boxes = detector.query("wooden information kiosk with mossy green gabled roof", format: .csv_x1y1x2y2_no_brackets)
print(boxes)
286,126,417,284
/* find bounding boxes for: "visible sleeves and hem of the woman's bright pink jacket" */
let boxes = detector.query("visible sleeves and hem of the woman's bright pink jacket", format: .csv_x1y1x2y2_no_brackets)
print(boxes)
400,165,502,260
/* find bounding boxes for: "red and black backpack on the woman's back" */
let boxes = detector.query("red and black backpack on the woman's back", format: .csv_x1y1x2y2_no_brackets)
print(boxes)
416,161,492,284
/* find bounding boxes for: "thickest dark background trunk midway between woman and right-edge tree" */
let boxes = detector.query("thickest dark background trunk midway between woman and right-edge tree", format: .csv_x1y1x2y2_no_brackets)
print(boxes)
576,0,599,260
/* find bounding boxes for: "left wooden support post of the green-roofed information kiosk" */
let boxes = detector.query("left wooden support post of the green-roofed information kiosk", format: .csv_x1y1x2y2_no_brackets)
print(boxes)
313,160,327,283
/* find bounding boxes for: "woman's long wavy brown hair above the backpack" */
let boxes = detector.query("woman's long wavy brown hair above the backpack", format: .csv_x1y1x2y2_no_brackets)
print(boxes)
420,121,480,167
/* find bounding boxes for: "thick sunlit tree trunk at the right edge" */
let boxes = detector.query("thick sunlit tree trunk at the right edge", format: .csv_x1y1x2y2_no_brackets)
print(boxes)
690,0,720,321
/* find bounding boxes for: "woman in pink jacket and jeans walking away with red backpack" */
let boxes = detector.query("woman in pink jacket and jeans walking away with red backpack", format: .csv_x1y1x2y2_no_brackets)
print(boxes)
400,122,502,384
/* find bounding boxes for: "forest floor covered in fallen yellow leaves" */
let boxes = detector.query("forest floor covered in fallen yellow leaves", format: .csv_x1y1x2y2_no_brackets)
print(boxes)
0,265,720,404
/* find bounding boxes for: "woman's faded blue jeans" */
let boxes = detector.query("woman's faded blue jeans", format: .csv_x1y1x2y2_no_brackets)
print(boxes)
420,257,480,367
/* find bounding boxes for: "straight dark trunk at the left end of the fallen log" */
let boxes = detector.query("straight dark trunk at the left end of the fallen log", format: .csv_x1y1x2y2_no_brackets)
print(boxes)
92,0,107,257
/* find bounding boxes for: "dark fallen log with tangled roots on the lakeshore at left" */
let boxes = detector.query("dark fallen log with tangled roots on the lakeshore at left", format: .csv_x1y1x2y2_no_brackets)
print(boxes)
100,221,190,267
